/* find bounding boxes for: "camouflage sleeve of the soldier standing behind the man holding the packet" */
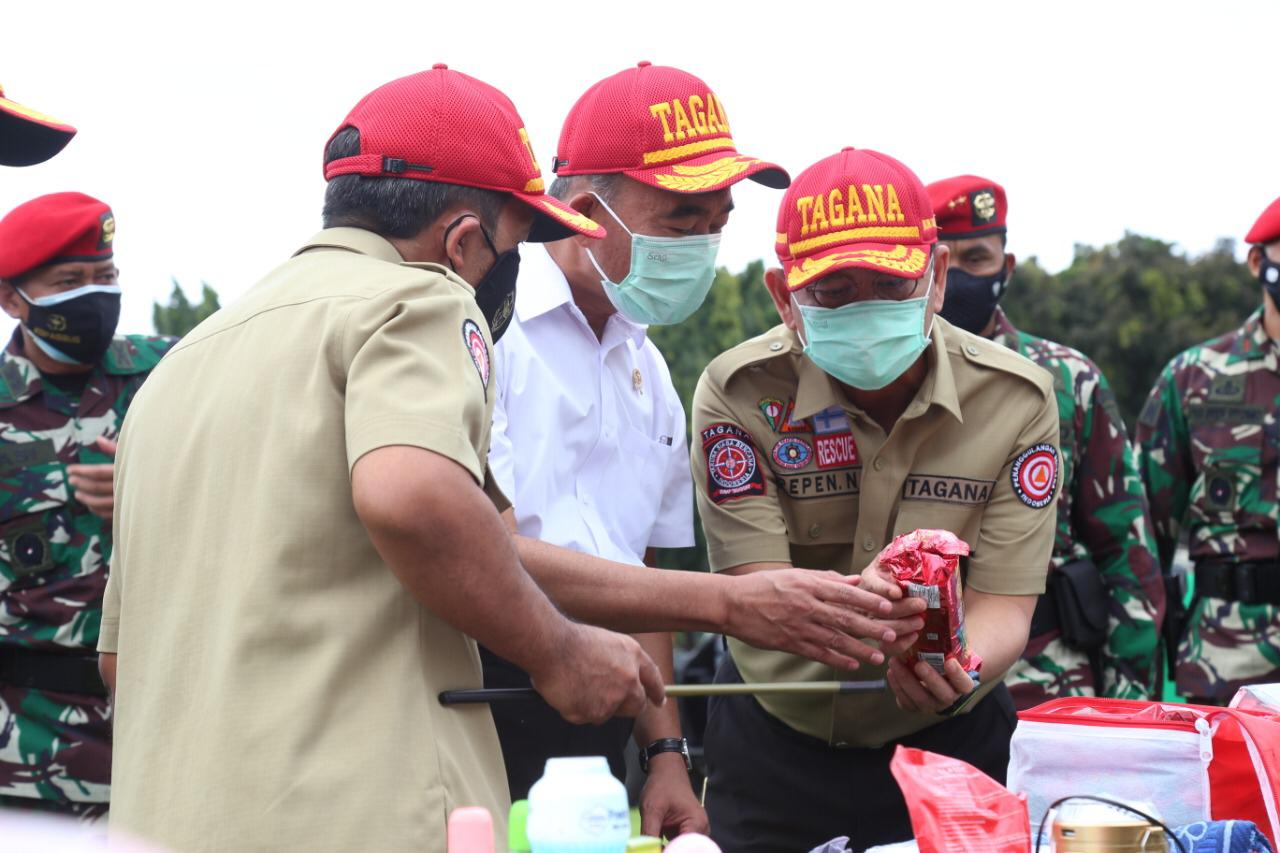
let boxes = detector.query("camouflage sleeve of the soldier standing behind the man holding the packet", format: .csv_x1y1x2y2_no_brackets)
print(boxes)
1071,371,1165,699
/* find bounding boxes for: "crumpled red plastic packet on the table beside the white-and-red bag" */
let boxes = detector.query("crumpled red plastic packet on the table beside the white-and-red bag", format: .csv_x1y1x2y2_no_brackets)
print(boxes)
888,745,1032,853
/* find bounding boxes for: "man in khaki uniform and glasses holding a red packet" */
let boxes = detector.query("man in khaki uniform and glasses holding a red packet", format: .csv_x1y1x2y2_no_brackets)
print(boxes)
691,149,1059,853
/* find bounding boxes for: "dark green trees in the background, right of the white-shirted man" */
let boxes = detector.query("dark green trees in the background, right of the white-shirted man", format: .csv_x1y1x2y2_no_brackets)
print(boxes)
649,234,1262,570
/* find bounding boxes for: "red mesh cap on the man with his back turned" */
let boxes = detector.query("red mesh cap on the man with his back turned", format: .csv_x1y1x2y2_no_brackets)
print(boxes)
324,63,605,242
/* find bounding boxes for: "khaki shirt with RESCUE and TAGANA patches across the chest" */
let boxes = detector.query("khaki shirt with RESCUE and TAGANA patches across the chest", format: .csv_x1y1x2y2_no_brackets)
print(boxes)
691,318,1059,747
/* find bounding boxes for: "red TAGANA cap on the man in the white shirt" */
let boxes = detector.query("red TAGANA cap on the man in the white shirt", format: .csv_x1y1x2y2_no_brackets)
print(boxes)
552,63,791,192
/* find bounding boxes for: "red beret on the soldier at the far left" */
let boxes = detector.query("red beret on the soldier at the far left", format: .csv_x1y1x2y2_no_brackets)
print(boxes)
0,192,115,278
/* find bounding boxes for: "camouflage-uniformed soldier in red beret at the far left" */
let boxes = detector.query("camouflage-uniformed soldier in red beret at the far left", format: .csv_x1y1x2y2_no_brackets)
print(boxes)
0,193,172,818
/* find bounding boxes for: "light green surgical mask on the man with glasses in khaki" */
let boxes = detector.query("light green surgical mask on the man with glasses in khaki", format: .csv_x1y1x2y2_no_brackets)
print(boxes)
794,257,933,391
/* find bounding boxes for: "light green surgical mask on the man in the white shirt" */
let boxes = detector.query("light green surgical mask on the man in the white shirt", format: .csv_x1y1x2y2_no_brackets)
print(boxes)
586,192,721,325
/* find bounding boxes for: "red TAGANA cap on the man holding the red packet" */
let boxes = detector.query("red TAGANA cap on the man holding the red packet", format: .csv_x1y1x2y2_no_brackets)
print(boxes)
776,147,938,291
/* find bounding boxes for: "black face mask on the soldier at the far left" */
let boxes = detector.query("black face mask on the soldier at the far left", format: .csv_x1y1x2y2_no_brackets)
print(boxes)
14,284,120,364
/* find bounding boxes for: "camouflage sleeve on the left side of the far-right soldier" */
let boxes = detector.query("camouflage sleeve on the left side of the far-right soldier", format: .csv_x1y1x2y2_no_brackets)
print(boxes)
1135,362,1196,570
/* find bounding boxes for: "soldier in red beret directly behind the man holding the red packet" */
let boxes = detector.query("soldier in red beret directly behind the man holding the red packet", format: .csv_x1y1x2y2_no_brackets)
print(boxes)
928,175,1165,710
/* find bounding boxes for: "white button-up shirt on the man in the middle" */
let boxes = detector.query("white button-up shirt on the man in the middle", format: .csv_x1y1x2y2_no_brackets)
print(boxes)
489,245,694,565
